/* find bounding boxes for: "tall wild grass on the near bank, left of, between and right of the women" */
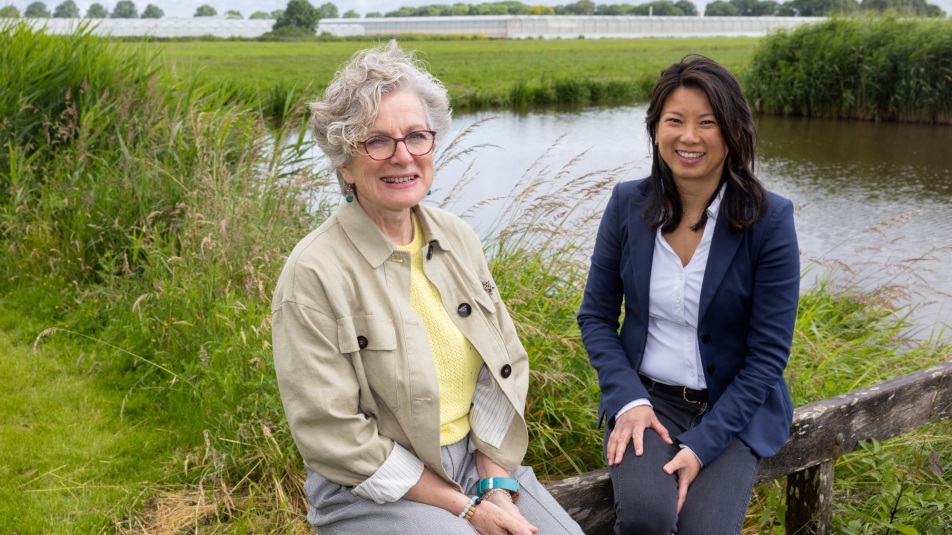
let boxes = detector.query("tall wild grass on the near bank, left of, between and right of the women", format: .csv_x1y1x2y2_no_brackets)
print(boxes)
0,25,952,533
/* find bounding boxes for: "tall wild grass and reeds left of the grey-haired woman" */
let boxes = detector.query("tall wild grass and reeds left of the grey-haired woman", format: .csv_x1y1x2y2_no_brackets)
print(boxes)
0,24,329,528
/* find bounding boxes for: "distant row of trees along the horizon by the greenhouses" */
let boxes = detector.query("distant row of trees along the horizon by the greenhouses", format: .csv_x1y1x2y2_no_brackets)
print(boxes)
0,0,946,20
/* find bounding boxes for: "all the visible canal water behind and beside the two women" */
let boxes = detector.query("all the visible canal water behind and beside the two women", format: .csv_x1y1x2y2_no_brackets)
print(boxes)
304,105,952,328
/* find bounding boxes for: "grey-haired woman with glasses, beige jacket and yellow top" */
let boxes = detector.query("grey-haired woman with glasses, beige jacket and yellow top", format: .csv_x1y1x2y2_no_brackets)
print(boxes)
273,42,581,535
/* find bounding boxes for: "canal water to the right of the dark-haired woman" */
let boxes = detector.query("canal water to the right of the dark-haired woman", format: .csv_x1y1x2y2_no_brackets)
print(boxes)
758,117,952,296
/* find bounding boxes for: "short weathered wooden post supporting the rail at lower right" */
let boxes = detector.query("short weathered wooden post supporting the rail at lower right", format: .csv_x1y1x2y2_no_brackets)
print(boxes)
785,459,836,535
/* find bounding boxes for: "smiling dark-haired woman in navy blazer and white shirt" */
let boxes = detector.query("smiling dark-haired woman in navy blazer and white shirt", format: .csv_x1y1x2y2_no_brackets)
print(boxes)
578,56,800,535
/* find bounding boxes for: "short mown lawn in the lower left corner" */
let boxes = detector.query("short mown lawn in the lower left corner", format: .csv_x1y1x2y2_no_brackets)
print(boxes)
0,299,192,535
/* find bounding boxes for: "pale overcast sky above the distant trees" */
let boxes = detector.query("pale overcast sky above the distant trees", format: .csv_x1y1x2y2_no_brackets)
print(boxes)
0,0,952,18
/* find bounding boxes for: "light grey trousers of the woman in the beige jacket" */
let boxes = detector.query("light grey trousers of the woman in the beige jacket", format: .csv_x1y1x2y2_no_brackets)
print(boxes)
304,438,583,535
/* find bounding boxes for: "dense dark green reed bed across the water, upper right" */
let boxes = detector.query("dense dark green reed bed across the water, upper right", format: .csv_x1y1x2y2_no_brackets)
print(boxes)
745,16,952,123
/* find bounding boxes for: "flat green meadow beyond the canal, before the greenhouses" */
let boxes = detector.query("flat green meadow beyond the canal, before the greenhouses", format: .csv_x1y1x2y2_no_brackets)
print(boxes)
145,37,760,101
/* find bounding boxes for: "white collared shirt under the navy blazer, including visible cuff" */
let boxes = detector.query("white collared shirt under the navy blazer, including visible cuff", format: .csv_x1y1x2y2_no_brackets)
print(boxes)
615,186,725,426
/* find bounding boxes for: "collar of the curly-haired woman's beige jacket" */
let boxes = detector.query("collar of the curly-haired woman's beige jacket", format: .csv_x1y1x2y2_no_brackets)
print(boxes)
337,202,450,269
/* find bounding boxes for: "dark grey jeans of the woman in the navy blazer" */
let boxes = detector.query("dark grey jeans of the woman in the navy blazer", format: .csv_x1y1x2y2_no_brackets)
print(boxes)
605,385,760,535
